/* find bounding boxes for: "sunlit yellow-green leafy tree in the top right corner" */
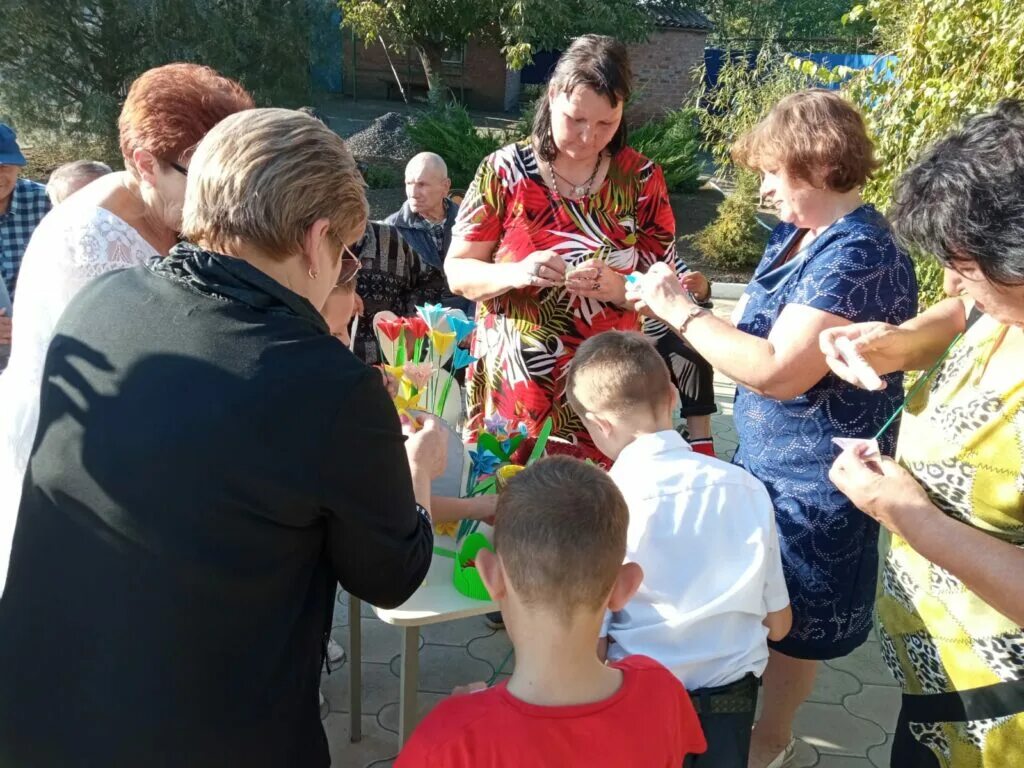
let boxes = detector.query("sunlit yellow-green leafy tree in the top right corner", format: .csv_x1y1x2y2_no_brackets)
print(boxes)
846,0,1024,304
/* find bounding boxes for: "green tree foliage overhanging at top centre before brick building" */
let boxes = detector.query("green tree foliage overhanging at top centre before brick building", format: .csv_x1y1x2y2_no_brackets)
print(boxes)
339,0,650,94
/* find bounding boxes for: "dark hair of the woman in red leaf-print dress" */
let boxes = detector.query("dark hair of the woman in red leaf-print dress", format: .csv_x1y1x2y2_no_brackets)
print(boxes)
534,35,633,163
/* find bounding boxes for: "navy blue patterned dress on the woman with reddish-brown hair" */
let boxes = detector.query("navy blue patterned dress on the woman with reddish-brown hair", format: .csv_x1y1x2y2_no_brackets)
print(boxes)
734,206,918,658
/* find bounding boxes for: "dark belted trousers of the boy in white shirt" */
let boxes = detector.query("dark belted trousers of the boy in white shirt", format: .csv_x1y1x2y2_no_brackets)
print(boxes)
683,674,758,768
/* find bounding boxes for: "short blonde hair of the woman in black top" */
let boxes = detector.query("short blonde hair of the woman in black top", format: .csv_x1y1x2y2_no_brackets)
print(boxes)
182,110,369,259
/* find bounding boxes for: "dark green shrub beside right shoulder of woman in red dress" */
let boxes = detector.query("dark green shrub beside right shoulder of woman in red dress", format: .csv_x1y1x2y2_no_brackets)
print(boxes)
630,109,700,193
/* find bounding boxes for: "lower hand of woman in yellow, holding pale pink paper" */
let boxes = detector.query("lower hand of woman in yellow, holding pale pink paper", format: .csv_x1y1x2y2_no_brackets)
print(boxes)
828,446,938,539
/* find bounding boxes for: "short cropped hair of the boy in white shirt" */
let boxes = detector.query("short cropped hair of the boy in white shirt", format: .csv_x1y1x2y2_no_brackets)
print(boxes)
565,331,674,417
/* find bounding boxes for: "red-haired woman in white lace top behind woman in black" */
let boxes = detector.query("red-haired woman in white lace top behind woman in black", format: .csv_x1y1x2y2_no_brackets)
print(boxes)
0,63,254,590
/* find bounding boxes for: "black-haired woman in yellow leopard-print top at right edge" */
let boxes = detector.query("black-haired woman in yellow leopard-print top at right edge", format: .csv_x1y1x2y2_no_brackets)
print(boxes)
821,102,1024,768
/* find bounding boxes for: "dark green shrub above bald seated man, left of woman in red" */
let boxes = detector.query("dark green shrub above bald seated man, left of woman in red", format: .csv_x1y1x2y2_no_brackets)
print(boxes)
408,103,501,188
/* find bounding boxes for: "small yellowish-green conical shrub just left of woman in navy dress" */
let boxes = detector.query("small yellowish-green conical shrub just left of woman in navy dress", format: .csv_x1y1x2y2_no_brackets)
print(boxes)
690,171,766,268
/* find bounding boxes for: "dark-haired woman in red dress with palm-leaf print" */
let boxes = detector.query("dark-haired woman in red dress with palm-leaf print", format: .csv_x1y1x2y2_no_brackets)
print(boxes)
444,35,708,465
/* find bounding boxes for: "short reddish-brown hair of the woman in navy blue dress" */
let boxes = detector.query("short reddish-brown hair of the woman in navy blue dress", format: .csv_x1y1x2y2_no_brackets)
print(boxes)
732,88,879,193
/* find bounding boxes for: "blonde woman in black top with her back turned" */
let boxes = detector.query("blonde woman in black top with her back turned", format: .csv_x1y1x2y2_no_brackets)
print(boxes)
0,110,444,768
